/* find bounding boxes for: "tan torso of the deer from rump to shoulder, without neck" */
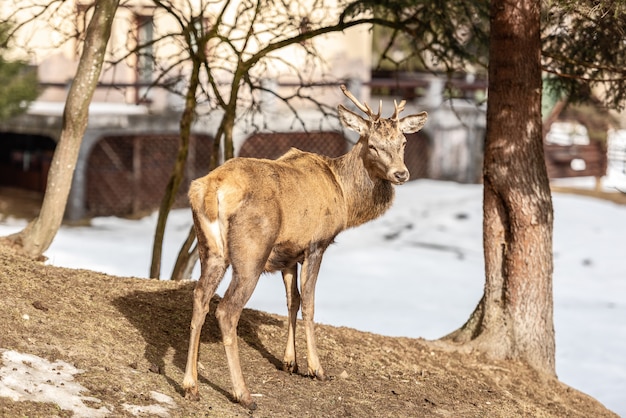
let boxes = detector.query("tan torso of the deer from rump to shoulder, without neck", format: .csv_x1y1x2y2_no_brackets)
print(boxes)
189,149,347,270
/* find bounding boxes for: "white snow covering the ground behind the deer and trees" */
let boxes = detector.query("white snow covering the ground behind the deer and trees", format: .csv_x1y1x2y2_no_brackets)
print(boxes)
0,173,626,416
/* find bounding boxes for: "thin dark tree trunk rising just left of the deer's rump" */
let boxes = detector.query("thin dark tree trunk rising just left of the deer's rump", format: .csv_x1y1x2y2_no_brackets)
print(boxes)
150,58,200,279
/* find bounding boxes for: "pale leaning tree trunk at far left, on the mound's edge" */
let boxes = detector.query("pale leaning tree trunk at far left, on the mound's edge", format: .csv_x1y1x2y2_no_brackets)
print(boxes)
9,0,119,258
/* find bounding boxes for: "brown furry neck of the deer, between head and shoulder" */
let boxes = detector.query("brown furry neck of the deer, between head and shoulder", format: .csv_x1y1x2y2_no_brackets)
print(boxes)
333,141,394,228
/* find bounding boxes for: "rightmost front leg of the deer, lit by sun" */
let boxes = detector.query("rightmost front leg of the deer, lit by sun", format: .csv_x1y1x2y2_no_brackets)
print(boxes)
300,244,326,380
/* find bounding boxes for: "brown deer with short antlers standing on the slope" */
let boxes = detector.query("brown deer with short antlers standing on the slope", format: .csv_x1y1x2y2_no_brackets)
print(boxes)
183,85,428,410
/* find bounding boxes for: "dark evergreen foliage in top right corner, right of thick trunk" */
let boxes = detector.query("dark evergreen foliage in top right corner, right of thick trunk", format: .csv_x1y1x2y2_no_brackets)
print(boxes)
542,0,626,110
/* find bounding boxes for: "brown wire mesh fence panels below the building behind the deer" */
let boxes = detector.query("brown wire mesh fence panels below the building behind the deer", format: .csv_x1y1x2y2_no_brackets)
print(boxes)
85,132,429,216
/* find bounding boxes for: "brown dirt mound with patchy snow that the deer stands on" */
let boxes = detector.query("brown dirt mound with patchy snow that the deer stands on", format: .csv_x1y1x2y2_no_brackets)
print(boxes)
0,246,616,418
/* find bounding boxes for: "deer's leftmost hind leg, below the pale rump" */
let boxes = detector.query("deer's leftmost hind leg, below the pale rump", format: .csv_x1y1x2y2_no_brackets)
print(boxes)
183,214,228,400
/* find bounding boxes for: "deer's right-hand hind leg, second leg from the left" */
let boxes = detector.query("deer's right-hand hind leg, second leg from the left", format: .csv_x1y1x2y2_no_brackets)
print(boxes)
215,264,262,410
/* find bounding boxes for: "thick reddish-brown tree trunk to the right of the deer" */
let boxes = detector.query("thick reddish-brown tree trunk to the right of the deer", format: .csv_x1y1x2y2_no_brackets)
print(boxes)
444,0,555,374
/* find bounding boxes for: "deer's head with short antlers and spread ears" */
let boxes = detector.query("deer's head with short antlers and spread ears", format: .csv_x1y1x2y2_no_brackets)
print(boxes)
337,85,428,184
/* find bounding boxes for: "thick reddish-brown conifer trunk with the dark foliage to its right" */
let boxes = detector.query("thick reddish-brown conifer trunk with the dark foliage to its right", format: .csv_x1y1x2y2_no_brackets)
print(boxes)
436,0,626,375
